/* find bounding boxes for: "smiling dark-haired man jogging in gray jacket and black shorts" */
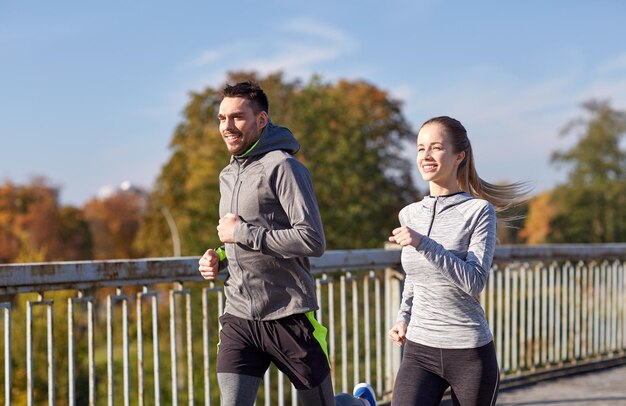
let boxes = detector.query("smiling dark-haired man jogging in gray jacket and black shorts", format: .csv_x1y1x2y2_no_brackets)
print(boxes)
199,82,375,406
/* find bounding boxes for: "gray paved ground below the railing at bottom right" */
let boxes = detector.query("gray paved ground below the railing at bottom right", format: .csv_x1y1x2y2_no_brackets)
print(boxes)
498,365,626,406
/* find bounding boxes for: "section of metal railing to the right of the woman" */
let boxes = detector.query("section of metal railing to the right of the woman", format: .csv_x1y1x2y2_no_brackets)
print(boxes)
481,244,626,384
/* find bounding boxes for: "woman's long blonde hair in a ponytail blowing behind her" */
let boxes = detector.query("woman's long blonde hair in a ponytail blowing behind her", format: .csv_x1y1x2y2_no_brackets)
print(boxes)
420,116,531,213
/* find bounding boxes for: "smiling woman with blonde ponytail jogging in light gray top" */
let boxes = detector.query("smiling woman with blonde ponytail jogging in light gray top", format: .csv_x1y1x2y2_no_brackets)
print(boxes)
388,116,526,406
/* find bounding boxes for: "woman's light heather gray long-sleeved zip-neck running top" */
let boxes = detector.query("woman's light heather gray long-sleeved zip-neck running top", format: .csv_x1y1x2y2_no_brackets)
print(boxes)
397,193,496,348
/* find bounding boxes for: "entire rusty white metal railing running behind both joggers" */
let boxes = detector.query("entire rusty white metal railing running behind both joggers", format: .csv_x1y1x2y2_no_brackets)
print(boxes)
0,244,626,405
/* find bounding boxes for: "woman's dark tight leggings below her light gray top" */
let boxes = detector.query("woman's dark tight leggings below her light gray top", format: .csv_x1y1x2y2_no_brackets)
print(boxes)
391,340,500,406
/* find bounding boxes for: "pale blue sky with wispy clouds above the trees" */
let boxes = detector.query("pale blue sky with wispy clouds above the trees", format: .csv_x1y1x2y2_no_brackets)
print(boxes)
0,0,626,205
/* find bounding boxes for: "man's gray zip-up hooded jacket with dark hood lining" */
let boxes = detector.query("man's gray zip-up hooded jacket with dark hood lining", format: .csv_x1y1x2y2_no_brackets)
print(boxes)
220,123,326,320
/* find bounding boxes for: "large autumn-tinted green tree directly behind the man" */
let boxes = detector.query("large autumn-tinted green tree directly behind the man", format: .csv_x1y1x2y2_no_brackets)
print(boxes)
136,72,418,256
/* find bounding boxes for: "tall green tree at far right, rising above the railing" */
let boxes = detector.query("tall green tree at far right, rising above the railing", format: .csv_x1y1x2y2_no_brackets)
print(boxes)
548,100,626,243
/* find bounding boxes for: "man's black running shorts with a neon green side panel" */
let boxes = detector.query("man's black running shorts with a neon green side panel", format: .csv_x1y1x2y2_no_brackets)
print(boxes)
217,312,330,390
